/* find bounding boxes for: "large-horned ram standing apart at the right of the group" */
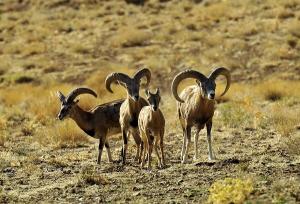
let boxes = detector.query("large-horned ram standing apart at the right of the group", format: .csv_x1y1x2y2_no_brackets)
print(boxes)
172,67,231,163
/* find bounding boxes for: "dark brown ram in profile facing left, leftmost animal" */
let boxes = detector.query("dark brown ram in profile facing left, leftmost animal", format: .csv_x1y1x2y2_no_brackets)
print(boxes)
57,87,124,165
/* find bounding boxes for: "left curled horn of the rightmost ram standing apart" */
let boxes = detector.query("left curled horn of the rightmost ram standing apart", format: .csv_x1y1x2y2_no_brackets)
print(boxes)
171,69,207,103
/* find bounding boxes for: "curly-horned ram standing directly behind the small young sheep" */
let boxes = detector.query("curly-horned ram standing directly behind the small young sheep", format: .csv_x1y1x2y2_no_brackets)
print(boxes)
105,68,151,164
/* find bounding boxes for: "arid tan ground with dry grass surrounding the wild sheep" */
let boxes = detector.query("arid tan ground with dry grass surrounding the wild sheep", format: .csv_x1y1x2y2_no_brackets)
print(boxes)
0,0,300,203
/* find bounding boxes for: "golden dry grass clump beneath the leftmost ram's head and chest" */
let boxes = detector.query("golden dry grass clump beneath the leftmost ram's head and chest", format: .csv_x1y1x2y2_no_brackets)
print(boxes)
35,120,89,148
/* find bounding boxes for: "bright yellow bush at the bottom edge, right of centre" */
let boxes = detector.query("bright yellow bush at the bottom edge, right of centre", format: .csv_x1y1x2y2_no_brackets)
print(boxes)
208,178,254,204
